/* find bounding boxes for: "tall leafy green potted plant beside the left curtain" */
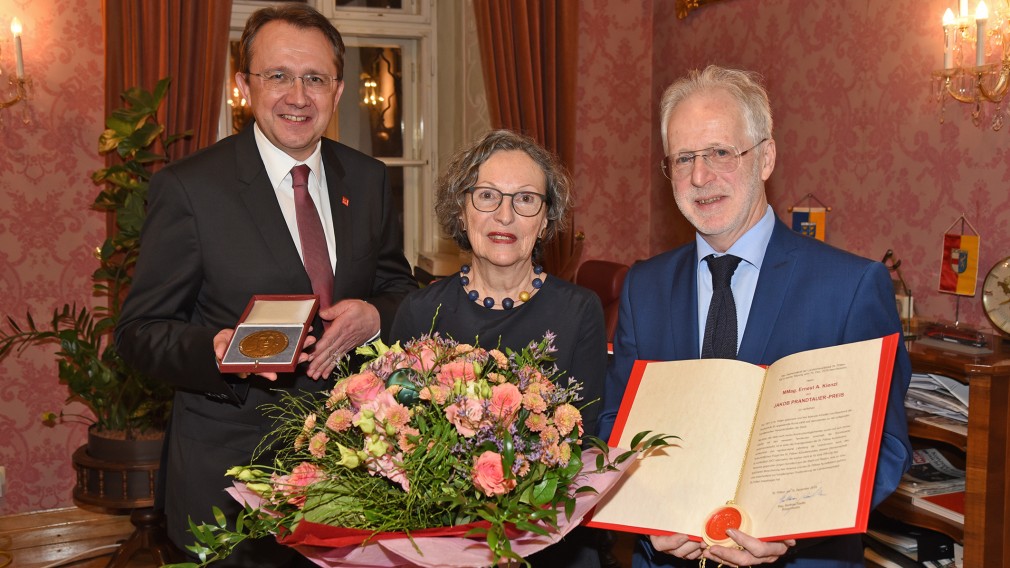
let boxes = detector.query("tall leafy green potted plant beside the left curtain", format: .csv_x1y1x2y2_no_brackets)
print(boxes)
0,78,190,508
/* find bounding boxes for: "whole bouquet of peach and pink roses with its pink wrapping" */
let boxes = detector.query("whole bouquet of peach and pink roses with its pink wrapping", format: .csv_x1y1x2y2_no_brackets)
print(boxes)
168,333,669,566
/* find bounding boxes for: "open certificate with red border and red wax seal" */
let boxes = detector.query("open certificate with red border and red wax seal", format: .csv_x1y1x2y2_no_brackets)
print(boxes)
590,334,899,543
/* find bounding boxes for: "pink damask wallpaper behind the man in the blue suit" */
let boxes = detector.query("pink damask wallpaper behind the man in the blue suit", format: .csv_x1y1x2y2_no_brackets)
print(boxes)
574,0,1010,329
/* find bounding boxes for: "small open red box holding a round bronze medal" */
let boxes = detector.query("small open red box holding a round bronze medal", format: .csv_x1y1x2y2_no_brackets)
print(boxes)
218,294,319,373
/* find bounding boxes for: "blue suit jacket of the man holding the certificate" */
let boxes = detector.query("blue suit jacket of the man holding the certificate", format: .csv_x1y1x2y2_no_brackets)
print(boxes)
599,220,911,568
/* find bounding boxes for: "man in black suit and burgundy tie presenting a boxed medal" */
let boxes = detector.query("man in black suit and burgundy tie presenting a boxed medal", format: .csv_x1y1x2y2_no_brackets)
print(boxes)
116,4,416,566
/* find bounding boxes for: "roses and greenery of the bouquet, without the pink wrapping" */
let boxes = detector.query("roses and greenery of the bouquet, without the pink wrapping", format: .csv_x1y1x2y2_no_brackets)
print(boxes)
173,336,673,568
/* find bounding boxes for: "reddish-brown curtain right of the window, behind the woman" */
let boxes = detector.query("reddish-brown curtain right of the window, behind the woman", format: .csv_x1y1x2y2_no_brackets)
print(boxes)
474,0,582,280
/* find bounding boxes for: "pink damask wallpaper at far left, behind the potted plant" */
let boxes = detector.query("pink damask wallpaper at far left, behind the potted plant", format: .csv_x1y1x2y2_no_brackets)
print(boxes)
0,0,105,514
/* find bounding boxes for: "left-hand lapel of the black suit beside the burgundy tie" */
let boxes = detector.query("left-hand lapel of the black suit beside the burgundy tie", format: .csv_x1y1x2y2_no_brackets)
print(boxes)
235,123,311,280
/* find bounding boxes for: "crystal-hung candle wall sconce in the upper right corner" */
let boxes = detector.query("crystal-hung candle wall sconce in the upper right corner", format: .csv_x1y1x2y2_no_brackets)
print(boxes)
932,0,1010,130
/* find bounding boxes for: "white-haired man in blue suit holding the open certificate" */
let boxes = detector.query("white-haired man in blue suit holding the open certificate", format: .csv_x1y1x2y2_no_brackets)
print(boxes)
600,66,911,568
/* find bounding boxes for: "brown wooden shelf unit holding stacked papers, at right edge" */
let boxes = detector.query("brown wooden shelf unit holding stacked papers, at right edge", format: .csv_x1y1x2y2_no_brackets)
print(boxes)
881,338,1010,568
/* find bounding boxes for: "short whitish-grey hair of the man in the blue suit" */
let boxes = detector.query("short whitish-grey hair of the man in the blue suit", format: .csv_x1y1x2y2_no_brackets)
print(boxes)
660,65,772,154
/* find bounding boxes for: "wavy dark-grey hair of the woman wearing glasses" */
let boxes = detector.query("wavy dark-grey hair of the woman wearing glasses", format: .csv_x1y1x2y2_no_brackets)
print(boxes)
435,130,574,259
